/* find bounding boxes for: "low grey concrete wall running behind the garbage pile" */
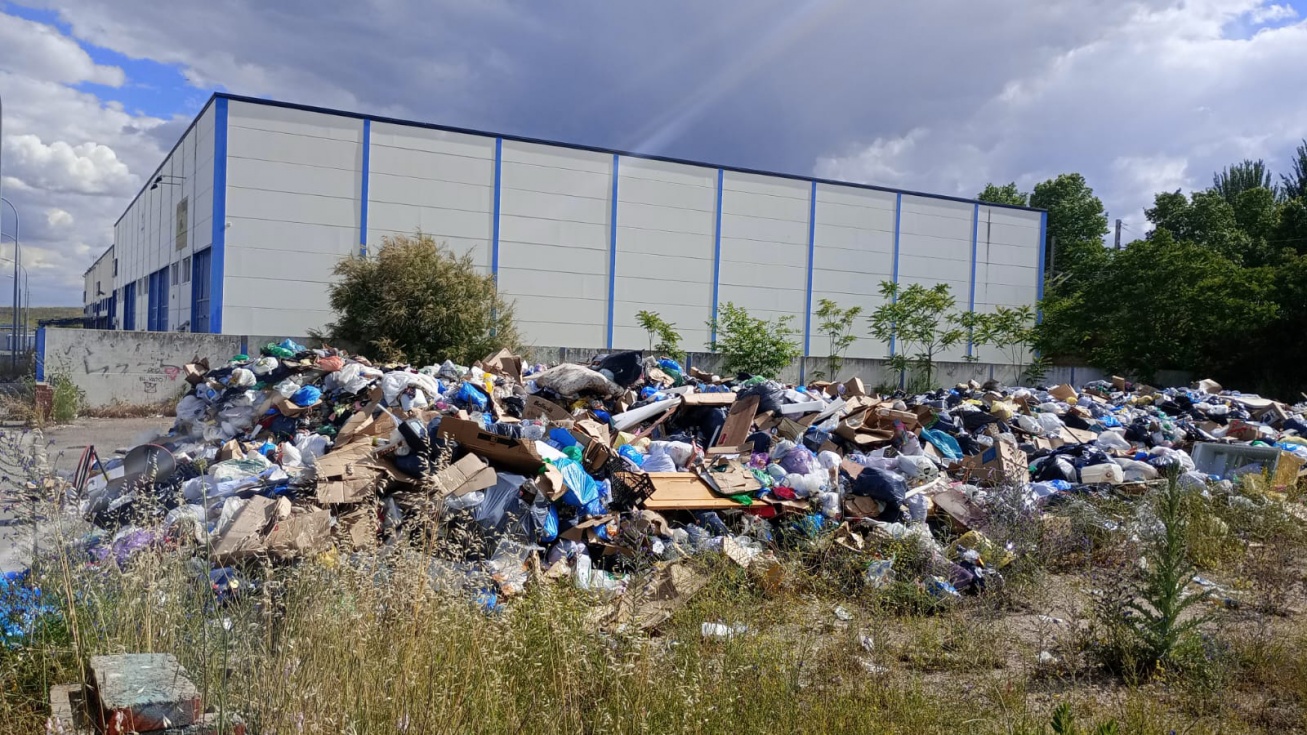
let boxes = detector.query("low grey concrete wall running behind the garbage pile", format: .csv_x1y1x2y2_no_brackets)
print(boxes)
37,328,1191,407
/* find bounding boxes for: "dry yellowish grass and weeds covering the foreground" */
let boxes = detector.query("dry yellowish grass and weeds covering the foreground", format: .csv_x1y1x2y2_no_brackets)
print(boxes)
0,436,1307,734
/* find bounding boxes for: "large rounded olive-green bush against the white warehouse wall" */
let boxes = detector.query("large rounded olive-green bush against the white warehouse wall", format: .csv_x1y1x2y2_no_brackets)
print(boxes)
318,231,519,365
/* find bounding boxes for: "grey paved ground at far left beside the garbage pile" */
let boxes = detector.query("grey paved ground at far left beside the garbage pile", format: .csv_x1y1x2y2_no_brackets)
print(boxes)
0,419,173,573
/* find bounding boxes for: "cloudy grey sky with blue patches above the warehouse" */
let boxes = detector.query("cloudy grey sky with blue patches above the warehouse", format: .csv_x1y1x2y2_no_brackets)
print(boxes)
0,0,1307,305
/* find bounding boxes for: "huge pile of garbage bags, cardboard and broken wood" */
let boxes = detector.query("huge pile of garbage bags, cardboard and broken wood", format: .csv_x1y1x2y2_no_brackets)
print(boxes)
81,340,1307,617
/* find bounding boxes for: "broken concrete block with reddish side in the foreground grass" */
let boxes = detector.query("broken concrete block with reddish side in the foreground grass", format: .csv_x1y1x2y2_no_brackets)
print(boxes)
90,654,204,735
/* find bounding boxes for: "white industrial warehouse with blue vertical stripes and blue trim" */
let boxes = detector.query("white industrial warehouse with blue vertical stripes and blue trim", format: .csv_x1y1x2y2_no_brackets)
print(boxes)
85,94,1046,360
